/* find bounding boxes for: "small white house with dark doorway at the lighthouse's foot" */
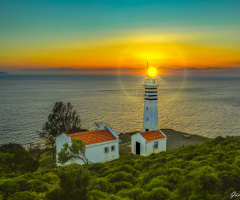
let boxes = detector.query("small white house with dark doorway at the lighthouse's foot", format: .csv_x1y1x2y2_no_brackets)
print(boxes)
131,129,167,156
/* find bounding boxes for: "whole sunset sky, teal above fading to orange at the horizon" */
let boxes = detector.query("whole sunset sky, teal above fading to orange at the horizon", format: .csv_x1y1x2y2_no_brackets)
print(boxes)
0,0,240,74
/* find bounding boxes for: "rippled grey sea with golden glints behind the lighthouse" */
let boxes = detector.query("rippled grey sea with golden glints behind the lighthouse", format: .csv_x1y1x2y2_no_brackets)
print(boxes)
0,75,240,145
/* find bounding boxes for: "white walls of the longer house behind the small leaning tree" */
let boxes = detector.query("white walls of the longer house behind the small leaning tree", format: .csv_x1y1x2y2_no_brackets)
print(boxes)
56,134,119,166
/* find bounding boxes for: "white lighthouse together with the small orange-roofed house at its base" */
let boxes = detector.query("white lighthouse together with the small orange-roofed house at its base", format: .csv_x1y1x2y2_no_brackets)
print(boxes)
131,68,167,156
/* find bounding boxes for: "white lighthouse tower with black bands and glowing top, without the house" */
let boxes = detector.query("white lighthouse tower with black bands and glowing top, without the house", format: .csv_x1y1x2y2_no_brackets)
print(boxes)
142,67,159,132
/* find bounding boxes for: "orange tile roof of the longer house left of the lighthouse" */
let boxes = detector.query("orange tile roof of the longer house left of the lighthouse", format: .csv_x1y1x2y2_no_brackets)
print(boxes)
67,129,116,145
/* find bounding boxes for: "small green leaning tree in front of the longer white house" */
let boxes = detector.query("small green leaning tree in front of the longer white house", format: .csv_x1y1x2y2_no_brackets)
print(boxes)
58,138,88,164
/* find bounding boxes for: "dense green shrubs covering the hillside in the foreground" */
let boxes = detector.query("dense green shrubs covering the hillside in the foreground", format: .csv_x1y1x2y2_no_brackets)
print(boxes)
0,137,240,200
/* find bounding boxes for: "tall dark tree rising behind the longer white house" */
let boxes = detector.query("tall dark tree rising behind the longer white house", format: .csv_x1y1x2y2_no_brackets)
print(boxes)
38,102,81,159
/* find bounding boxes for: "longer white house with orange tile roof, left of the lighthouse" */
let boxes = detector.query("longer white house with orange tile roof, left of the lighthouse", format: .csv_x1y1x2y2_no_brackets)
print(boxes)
56,126,119,166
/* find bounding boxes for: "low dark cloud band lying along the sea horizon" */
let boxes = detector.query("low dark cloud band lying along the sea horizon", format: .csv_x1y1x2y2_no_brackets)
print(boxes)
3,64,240,74
